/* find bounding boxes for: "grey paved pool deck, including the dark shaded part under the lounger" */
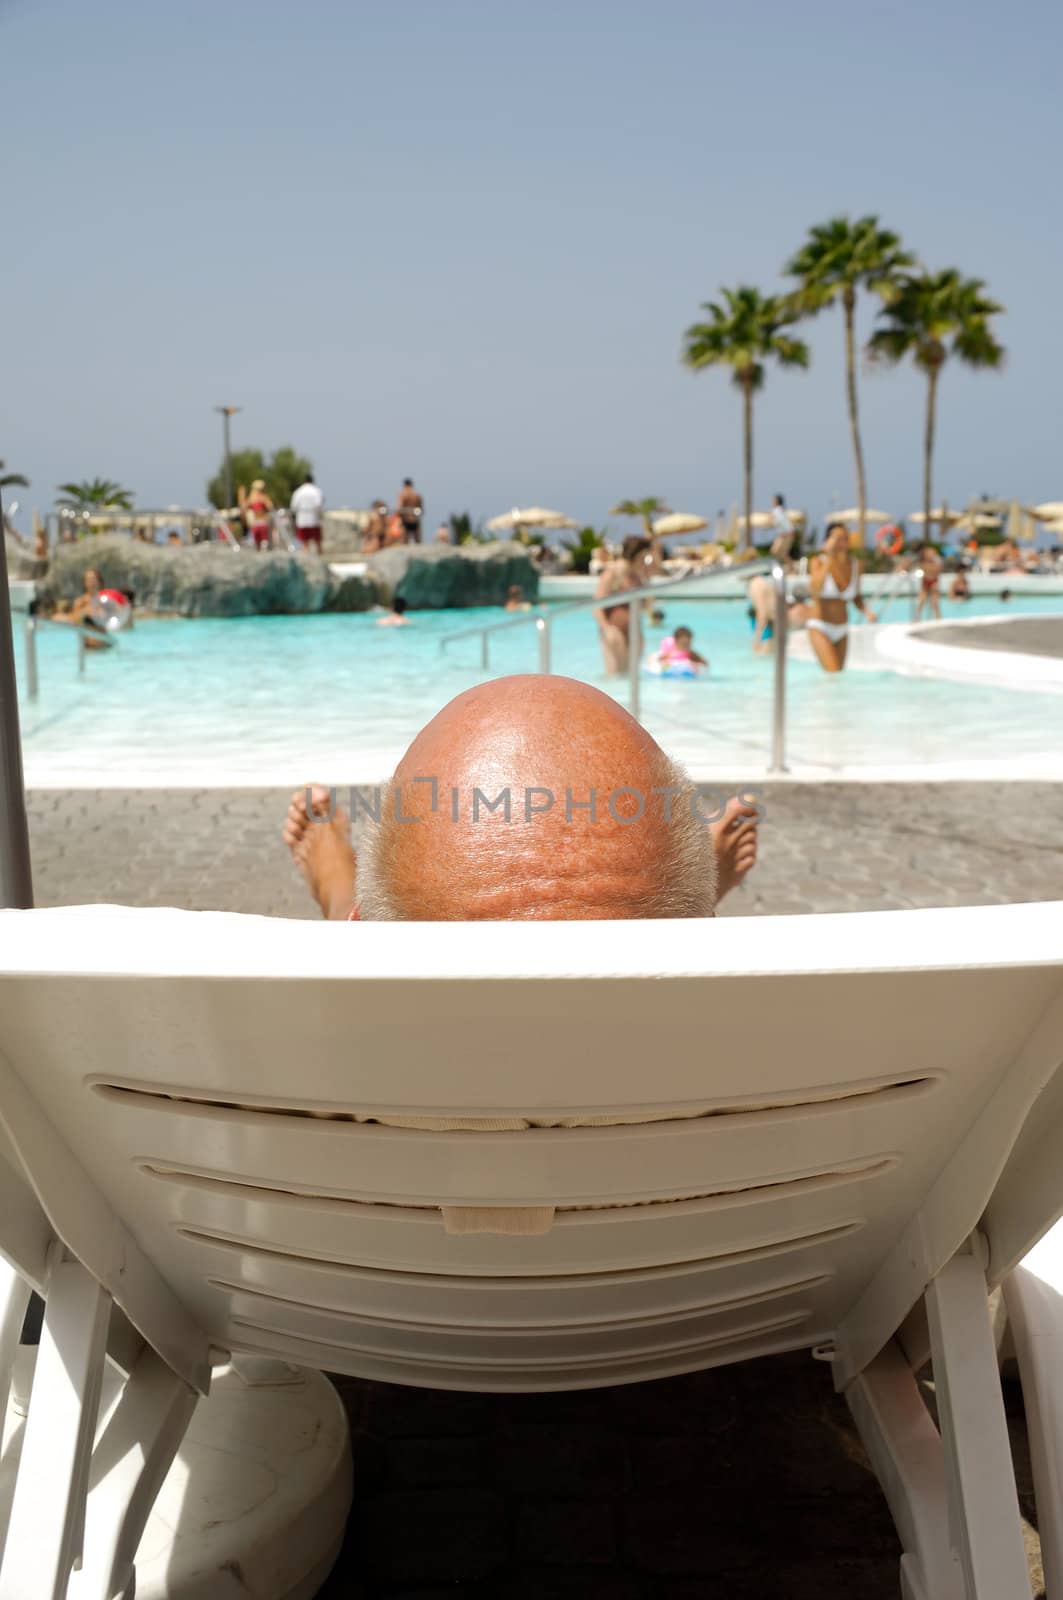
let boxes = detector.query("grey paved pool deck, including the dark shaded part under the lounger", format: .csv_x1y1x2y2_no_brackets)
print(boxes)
29,784,1063,1600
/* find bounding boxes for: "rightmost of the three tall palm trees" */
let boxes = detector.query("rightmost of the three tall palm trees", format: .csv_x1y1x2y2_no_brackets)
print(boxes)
868,267,1004,538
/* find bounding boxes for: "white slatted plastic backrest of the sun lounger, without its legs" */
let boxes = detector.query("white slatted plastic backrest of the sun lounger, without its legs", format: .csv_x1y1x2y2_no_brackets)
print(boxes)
0,906,1063,1389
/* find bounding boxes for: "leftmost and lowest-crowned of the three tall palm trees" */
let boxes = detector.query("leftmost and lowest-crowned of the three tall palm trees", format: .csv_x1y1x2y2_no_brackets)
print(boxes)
682,283,808,546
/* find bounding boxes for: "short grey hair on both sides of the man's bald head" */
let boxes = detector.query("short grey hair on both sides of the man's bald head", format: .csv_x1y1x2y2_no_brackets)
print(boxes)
357,755,717,922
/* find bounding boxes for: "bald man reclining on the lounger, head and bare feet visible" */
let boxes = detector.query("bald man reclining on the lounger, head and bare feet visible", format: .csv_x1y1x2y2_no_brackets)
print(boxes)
283,675,759,922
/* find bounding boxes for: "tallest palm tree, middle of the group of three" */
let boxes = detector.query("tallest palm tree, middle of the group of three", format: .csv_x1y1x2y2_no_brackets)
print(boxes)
784,216,916,544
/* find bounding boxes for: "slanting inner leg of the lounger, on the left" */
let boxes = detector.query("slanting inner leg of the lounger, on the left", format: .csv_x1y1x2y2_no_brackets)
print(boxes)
70,1346,197,1600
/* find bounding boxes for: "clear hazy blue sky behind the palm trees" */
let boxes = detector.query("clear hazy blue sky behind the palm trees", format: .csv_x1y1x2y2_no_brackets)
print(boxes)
0,0,1063,537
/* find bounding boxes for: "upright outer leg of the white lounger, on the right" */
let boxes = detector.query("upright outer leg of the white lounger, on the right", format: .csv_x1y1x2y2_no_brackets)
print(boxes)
927,1254,1029,1600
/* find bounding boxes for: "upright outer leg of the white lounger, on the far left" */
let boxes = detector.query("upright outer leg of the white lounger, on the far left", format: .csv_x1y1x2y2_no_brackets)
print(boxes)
0,1261,110,1600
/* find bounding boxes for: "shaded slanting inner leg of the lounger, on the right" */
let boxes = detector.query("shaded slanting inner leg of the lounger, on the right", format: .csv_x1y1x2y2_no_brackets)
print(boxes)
845,1341,964,1600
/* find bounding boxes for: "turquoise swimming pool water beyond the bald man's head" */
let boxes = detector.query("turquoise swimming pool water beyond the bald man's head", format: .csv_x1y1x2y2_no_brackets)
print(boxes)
16,595,1063,787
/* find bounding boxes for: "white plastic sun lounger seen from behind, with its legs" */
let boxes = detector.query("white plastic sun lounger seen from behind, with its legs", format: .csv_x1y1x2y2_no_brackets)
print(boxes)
0,904,1063,1600
